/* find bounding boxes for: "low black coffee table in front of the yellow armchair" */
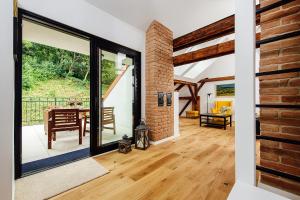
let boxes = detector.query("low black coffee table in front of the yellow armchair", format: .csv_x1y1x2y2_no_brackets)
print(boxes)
200,113,232,130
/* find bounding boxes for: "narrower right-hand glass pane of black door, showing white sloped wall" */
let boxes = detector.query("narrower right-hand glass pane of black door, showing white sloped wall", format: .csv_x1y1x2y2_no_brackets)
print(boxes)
99,50,134,146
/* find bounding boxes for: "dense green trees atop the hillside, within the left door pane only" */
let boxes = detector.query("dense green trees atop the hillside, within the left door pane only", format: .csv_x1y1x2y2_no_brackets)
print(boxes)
23,41,90,90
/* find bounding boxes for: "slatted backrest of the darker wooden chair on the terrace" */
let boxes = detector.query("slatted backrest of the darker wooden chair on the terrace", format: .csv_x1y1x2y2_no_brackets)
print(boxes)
51,109,80,128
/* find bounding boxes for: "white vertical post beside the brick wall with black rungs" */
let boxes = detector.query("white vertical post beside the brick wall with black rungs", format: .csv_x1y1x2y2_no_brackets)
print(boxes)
234,0,256,187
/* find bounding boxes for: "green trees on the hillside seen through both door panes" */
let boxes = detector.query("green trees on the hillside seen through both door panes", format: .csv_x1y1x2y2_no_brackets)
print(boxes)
22,41,117,96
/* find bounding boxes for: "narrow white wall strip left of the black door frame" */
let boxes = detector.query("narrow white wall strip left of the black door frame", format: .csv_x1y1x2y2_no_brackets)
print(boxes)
0,0,14,200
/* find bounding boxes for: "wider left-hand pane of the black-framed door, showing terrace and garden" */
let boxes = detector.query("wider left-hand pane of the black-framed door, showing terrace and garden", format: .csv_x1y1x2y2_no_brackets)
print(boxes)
20,19,90,166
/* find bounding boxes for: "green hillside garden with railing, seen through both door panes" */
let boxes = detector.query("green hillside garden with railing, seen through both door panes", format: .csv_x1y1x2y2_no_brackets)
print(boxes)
22,41,117,125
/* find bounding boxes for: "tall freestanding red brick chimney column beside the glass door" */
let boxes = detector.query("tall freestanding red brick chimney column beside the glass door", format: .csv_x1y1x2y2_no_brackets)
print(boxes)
145,21,174,141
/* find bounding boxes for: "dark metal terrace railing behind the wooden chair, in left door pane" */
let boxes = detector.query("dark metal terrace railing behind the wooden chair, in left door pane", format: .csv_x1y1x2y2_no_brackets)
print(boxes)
22,97,90,126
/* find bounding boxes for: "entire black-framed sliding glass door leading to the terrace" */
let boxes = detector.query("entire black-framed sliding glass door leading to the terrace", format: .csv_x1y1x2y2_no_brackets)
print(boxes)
14,9,141,178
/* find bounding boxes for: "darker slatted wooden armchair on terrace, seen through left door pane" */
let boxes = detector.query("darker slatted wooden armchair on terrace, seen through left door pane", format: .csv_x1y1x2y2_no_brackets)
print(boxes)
48,109,82,149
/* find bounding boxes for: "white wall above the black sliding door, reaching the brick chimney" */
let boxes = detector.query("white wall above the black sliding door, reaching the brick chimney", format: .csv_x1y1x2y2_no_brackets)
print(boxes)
19,0,145,115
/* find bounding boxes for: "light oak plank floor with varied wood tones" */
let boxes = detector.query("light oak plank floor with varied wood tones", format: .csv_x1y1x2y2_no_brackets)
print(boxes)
53,119,234,200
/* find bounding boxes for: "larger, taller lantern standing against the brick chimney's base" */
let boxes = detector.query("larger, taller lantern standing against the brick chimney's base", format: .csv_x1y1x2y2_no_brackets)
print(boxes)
135,120,150,150
